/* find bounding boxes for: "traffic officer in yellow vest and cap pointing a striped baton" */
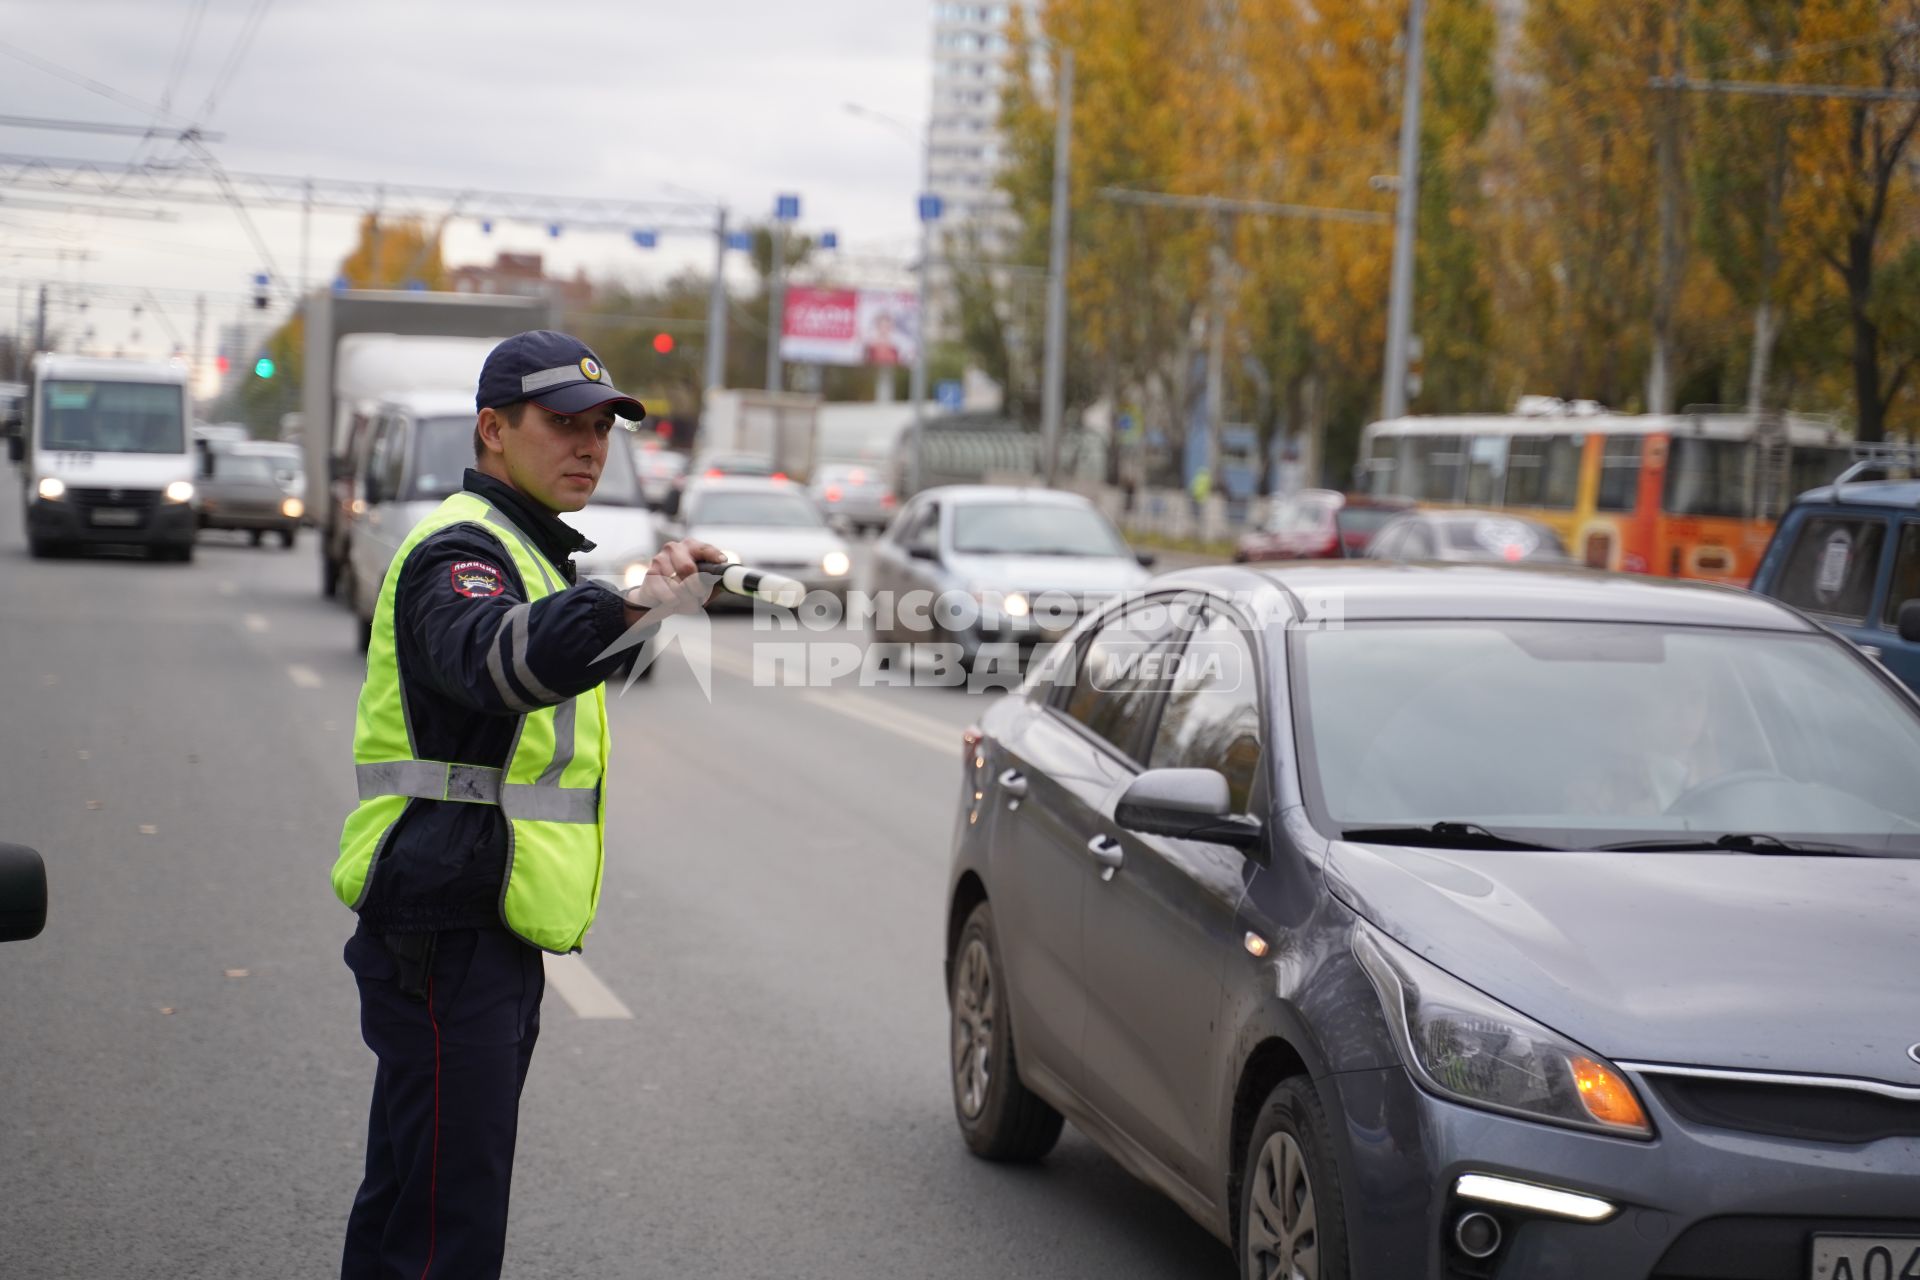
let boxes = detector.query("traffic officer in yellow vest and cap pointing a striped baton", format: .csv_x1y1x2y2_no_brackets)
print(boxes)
332,330,724,1280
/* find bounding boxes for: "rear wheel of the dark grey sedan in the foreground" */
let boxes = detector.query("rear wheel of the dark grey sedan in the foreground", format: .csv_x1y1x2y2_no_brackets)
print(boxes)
947,902,1064,1163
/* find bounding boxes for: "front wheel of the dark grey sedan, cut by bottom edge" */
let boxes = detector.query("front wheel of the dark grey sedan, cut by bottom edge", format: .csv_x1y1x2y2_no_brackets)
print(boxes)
1235,1077,1348,1280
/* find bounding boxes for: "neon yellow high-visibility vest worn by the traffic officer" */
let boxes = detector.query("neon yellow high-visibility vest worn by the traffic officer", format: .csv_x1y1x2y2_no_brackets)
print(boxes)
332,493,609,952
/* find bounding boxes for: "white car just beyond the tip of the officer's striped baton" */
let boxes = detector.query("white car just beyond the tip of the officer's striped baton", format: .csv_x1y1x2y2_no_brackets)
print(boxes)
680,476,852,603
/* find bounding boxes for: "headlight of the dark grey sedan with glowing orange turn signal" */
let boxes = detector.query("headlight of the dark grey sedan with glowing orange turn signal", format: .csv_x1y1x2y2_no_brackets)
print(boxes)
1354,925,1653,1138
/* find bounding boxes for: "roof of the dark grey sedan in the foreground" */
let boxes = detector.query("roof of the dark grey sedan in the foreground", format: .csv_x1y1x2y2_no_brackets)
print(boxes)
1154,560,1816,631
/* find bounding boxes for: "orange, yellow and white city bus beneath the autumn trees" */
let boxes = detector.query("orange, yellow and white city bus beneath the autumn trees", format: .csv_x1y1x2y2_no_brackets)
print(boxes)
1357,401,1851,585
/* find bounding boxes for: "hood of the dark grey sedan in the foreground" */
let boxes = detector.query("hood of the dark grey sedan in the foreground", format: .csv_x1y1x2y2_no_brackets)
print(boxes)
1329,842,1920,1086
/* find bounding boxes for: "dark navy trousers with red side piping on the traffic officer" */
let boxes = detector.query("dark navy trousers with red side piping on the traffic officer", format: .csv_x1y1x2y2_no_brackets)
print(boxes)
340,925,547,1280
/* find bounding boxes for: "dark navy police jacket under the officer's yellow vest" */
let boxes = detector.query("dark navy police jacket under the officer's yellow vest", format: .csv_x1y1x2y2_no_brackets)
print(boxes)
359,468,630,933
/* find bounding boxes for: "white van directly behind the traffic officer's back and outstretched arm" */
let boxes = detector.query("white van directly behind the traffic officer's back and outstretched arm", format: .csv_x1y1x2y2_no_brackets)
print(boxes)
348,391,662,649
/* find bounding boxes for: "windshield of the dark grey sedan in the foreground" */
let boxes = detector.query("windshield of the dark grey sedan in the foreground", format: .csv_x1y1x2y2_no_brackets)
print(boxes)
1292,622,1920,856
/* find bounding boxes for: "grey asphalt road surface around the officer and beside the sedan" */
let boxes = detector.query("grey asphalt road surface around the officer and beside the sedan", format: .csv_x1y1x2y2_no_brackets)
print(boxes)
0,476,1233,1280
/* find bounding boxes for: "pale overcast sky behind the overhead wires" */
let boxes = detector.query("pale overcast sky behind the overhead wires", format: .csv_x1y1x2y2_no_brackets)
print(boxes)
0,0,933,353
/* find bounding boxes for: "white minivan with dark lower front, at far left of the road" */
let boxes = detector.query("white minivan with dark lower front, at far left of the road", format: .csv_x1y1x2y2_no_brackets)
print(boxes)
8,353,196,560
